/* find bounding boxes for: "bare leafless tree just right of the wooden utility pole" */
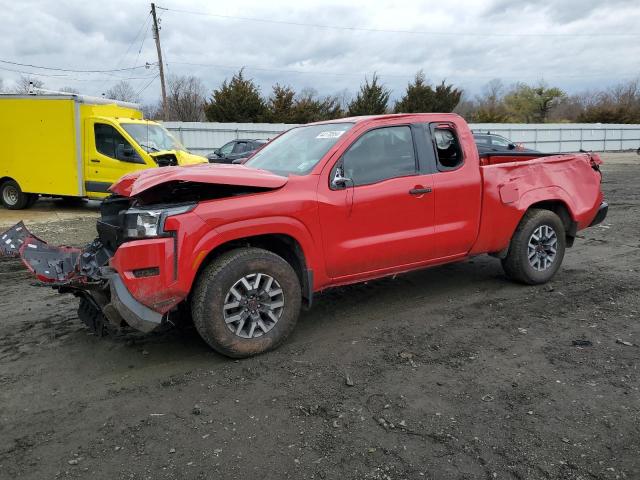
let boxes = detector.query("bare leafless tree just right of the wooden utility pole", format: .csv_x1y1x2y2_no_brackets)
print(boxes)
164,75,206,122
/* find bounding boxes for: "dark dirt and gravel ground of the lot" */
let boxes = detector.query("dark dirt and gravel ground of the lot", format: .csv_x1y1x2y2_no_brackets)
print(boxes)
0,155,640,480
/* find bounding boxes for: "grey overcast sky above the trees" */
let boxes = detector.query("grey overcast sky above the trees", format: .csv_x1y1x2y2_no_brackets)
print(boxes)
0,0,640,102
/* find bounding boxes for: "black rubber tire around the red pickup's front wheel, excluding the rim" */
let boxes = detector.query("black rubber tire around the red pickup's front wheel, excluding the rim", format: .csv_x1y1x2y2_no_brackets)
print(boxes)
191,248,302,358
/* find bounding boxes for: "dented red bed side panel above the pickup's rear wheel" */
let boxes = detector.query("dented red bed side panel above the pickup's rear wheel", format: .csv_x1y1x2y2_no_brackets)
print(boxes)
470,154,602,254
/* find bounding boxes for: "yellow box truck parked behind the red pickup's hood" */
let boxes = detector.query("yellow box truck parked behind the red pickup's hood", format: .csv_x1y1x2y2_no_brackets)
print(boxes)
0,93,207,210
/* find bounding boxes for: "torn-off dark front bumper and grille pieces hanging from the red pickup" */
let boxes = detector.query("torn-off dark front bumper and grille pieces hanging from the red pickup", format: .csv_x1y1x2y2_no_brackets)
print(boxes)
0,222,167,332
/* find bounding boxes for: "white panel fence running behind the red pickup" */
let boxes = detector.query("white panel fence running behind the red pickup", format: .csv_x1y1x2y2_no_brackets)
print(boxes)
164,122,640,154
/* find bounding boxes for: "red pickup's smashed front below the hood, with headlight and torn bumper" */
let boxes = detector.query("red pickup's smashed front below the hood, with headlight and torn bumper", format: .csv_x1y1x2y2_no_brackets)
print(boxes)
0,196,195,335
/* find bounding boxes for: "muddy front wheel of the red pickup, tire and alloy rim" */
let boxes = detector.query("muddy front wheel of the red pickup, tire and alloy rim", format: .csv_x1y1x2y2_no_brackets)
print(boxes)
191,248,301,358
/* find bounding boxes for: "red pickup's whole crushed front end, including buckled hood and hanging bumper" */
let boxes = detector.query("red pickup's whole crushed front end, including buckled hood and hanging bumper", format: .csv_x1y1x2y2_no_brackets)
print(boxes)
0,163,287,334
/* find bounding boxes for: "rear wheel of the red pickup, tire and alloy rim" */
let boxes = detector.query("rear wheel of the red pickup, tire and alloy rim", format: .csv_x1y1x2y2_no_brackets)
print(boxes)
502,209,566,285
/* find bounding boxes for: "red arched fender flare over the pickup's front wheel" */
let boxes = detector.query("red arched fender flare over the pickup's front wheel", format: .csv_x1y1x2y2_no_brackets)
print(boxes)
185,216,325,289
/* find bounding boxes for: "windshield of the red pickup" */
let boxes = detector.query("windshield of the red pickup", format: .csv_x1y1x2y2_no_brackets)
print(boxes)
245,123,353,176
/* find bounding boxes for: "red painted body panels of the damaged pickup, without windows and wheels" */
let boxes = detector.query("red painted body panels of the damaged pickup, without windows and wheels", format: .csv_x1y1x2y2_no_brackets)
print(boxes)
111,114,602,313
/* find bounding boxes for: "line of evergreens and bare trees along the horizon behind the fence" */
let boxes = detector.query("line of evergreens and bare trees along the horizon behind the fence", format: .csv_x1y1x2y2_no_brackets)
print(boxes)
5,69,640,123
